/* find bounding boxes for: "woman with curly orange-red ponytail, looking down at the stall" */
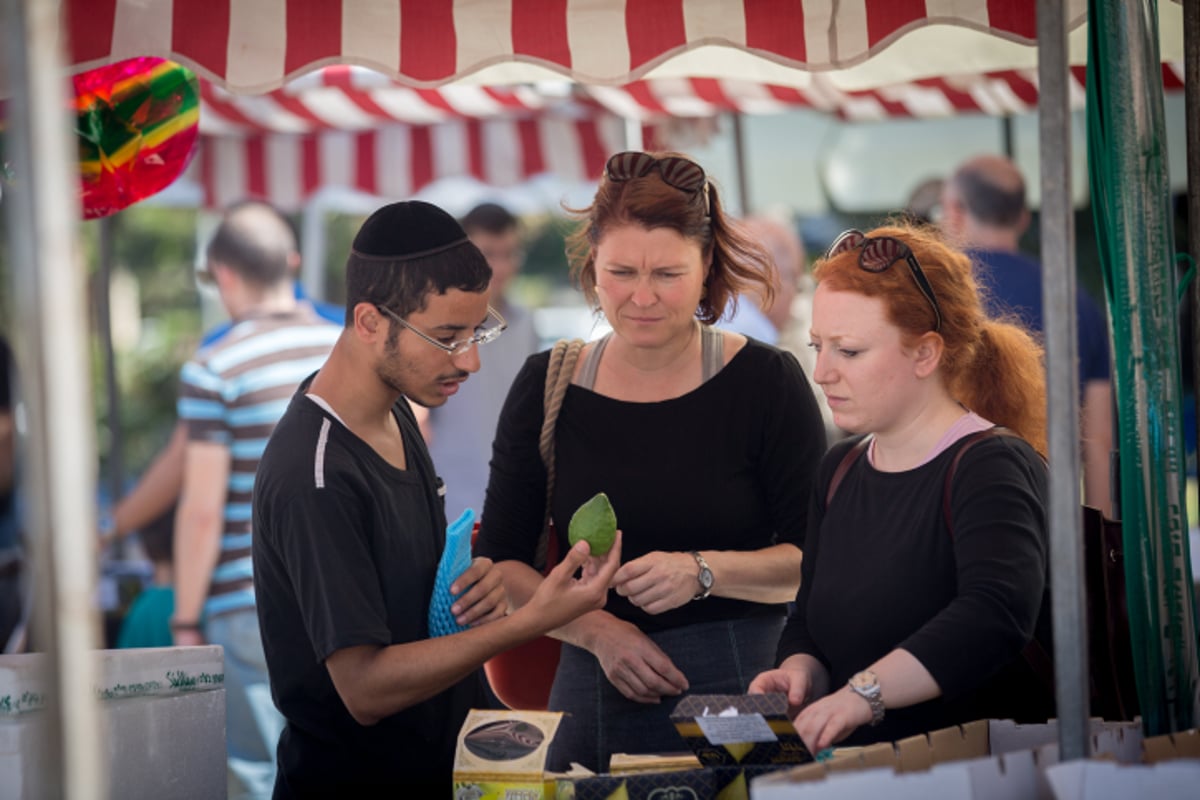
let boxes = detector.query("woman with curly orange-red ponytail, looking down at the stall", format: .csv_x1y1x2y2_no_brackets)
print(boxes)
751,225,1054,751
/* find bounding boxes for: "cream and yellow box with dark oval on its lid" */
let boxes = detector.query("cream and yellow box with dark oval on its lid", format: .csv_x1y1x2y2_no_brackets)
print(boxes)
454,709,563,800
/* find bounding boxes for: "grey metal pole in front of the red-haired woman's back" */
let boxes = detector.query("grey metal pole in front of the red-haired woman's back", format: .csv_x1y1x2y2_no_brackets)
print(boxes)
1038,0,1088,760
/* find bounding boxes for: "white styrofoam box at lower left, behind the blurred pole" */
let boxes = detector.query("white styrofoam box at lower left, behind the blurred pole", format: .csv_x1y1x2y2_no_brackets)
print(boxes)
0,645,227,800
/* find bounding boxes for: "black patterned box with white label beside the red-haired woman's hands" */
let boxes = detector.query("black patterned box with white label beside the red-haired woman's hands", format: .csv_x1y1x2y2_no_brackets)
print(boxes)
671,693,812,766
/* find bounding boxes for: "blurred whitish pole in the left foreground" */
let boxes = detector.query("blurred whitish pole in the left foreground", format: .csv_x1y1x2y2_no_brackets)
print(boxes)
0,0,108,798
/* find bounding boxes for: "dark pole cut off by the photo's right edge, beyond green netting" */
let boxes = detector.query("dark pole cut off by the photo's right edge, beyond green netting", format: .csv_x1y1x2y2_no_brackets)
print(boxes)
1183,1,1200,479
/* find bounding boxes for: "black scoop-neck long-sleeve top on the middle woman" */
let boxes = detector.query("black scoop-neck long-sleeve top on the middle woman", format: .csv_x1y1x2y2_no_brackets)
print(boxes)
475,339,826,632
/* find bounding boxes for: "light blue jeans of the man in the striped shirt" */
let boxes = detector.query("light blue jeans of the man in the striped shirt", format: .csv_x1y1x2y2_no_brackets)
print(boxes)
204,608,283,800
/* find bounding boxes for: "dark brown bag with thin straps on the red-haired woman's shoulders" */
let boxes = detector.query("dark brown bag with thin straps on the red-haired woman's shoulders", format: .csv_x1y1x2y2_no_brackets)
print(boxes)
826,426,1139,721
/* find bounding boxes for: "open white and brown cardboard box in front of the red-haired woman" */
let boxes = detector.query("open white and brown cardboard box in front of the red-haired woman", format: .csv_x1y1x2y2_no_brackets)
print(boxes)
750,720,1141,800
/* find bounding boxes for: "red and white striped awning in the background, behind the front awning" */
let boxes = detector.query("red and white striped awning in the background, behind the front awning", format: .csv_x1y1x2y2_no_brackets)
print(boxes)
192,57,1183,210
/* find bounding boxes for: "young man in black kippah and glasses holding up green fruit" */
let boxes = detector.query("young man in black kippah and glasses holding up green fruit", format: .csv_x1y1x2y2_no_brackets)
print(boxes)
253,201,620,798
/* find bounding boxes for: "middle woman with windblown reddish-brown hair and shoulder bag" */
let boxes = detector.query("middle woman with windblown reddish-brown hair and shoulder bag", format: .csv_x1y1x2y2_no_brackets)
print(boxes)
475,152,824,770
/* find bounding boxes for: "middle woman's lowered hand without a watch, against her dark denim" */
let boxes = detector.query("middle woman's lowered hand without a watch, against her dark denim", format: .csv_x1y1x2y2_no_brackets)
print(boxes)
588,618,688,703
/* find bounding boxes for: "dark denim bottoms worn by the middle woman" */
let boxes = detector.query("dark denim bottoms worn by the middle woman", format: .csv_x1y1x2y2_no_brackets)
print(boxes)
547,615,784,772
